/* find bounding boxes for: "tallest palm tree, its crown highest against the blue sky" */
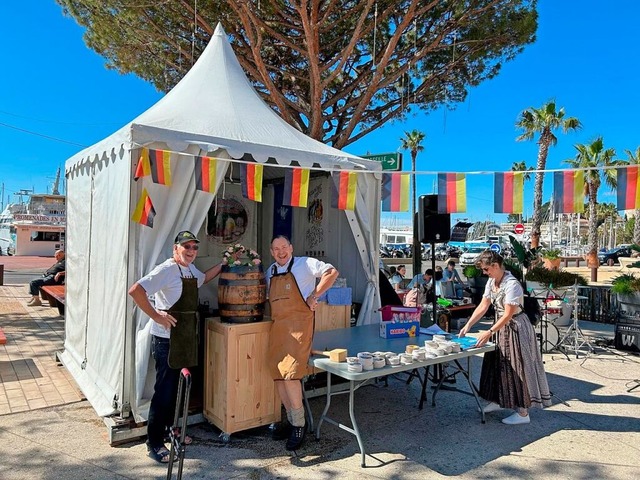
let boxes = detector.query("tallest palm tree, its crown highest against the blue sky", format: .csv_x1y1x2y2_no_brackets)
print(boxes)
516,100,582,247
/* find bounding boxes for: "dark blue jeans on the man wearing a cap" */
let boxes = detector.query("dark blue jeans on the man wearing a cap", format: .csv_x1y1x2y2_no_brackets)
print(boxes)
147,335,180,448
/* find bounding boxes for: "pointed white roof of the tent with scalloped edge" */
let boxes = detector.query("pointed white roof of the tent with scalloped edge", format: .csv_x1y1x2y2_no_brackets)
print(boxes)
67,24,381,171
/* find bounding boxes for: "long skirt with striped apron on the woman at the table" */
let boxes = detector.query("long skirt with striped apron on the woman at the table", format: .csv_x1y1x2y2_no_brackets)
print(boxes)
480,313,551,410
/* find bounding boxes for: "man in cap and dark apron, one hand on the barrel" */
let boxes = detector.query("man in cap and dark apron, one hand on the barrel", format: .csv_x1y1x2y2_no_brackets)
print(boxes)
129,230,229,463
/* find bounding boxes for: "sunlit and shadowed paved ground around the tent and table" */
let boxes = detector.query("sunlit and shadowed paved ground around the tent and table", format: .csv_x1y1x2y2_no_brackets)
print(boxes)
0,257,640,480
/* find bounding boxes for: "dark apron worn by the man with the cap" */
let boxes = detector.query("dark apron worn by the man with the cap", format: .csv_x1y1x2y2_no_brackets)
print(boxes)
167,266,199,368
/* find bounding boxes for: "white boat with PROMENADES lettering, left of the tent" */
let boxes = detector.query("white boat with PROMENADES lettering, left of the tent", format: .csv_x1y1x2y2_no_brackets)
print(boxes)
0,169,67,257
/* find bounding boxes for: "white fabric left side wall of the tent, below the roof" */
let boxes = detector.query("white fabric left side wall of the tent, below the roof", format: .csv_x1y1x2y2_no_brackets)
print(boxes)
62,152,130,415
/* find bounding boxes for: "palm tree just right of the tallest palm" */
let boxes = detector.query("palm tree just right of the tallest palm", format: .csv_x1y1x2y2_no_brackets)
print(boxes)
565,137,620,281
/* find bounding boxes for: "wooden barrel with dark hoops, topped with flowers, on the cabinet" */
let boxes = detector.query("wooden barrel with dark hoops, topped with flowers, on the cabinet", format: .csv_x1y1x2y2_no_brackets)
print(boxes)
218,264,267,323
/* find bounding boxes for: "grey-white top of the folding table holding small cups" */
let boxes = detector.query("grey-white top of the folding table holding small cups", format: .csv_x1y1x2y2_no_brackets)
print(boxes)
309,324,495,381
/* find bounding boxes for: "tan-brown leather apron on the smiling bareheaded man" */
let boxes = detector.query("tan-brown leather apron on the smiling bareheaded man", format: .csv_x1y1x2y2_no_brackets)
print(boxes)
269,258,314,380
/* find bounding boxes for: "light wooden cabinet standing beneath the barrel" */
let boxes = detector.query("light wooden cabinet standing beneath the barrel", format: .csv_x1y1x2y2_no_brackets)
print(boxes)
203,318,281,434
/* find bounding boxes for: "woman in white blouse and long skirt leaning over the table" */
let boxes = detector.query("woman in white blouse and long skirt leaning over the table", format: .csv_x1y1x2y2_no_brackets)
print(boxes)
460,250,551,425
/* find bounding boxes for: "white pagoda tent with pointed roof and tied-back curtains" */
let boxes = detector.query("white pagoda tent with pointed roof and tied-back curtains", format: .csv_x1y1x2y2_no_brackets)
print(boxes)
61,26,380,420
